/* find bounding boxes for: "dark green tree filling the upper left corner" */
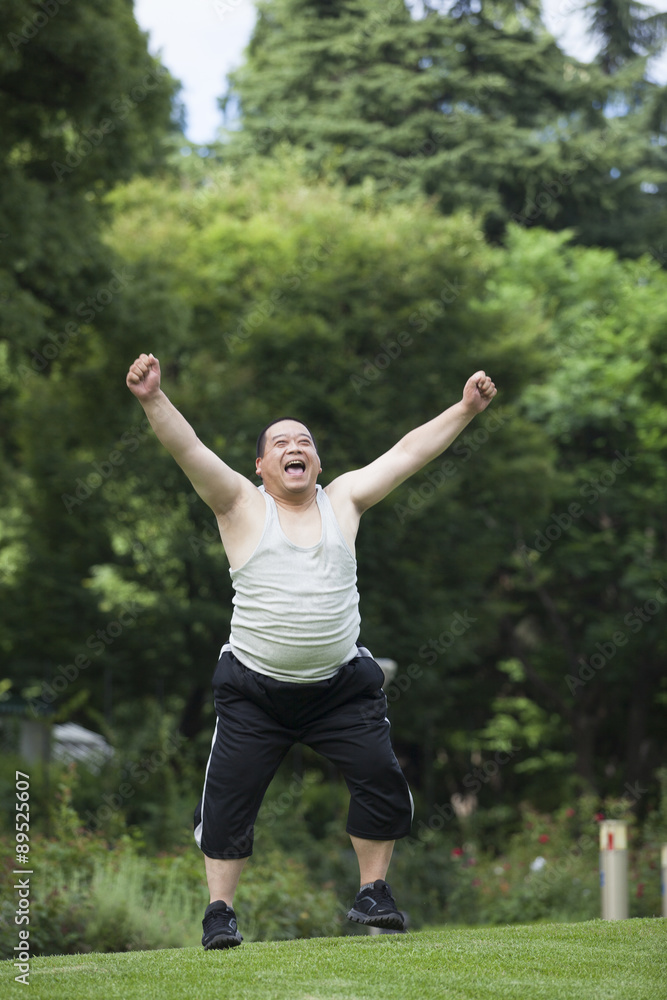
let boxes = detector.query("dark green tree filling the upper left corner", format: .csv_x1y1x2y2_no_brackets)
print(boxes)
0,0,176,377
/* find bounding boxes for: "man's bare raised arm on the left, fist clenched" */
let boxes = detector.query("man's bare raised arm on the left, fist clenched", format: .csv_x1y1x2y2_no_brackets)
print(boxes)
126,354,250,514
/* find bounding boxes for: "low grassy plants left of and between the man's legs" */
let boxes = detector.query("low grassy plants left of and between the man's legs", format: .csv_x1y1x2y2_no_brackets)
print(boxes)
0,769,343,958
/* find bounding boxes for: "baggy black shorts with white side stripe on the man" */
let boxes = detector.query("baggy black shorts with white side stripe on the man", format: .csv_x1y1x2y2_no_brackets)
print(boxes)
195,647,412,859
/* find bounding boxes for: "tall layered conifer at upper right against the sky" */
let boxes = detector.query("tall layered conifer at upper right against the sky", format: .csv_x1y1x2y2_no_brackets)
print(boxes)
223,0,666,256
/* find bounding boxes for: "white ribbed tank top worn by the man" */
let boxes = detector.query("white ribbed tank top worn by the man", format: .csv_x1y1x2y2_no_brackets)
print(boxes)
229,486,361,683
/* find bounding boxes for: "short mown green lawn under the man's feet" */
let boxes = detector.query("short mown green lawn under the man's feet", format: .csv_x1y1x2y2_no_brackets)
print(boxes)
0,919,667,1000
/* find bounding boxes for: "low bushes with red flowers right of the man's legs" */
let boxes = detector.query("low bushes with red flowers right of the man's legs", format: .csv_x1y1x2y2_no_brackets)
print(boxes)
391,793,667,925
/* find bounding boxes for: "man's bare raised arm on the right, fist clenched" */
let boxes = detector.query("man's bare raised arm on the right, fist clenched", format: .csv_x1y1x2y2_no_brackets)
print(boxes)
327,371,497,515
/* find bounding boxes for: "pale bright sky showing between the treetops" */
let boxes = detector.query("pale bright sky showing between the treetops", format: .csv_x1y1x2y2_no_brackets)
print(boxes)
134,0,667,145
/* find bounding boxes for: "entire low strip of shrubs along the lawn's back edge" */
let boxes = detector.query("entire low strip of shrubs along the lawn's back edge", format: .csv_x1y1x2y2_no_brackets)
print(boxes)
0,775,667,958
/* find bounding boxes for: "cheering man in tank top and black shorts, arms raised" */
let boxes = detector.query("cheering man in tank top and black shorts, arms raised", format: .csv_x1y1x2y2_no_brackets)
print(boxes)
127,354,496,949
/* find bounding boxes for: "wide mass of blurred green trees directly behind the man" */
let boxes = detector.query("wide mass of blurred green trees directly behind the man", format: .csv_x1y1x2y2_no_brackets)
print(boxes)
0,146,667,820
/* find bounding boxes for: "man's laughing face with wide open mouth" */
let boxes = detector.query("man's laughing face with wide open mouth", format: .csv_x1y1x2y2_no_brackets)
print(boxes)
255,420,322,494
